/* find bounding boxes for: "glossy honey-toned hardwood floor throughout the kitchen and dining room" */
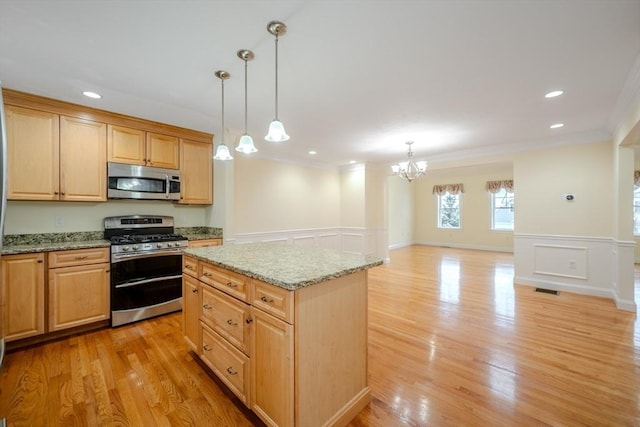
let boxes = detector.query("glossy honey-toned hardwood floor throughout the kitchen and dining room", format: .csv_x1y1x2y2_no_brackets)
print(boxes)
0,246,640,427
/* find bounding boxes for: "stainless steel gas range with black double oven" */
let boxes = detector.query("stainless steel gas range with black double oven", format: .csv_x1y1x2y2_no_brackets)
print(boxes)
104,215,189,326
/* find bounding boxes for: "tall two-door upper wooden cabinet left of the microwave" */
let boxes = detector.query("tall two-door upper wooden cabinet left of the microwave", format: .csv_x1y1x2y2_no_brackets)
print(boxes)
6,105,106,201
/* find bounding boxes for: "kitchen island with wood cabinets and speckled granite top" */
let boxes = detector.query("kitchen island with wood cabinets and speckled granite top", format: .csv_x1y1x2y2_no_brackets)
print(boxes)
183,243,382,427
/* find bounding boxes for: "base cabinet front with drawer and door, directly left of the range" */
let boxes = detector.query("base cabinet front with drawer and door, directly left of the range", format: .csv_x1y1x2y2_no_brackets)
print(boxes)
48,248,110,332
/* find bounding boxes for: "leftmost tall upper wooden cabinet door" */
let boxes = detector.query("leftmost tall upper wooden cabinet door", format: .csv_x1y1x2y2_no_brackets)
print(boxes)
5,105,60,200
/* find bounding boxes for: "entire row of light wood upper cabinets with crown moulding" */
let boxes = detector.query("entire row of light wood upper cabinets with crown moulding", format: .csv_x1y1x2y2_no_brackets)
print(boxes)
2,89,213,204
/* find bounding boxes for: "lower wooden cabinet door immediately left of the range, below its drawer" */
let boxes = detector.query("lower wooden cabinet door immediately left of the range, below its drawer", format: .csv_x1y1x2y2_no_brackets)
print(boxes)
49,263,110,331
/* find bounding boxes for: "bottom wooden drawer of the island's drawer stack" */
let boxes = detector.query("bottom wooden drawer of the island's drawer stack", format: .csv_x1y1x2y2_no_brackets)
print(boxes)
201,324,250,406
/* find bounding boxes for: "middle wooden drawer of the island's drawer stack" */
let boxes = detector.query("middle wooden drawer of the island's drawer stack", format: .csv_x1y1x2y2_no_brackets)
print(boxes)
202,286,250,354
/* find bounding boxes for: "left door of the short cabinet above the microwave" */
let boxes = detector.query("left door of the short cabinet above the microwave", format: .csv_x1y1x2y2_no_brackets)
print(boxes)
107,125,146,166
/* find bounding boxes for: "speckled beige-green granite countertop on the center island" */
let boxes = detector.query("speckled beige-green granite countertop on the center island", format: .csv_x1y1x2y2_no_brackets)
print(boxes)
184,243,382,291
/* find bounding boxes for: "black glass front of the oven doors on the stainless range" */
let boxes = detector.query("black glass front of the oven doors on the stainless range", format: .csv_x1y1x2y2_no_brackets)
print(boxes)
111,254,182,310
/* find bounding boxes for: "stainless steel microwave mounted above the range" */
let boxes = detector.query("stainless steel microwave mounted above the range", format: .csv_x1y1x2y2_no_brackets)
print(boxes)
107,162,180,200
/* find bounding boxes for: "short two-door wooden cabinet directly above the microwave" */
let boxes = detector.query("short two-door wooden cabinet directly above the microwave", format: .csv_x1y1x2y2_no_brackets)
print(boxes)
107,125,180,169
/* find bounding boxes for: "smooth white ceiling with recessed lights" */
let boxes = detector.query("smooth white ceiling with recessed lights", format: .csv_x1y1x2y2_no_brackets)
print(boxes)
0,0,640,166
